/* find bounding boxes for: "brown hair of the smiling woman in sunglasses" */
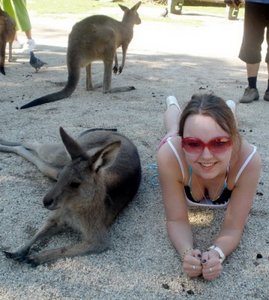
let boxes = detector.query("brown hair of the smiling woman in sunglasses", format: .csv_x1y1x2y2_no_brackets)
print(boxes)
179,94,241,149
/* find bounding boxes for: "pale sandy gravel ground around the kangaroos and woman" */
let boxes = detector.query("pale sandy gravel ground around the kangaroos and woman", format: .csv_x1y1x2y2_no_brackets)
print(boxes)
0,6,269,300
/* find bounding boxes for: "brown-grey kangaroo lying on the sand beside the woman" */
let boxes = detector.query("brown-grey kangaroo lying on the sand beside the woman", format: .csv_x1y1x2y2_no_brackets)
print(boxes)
0,128,141,266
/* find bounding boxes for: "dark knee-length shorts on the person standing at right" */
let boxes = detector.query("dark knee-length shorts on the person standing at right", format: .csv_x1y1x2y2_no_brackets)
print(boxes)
239,2,269,64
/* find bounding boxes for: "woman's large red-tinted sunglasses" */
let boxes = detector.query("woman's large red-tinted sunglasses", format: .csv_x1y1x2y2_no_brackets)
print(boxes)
181,136,232,154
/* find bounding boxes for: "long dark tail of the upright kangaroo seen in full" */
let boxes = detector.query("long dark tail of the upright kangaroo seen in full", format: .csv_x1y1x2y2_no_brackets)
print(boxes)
20,74,79,109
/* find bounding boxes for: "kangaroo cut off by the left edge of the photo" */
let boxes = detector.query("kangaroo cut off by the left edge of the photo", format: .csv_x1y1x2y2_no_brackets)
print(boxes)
0,7,16,75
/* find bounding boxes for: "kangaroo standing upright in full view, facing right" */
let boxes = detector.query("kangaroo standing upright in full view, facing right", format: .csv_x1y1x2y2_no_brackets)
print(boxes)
21,2,141,109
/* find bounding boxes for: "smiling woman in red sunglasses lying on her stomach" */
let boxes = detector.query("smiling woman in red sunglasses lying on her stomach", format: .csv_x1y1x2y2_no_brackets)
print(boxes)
157,94,261,280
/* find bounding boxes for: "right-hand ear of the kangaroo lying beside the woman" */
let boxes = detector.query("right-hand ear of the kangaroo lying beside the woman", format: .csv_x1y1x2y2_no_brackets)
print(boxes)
92,141,121,171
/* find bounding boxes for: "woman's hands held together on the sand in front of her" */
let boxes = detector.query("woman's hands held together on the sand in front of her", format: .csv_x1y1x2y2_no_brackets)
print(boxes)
183,249,222,280
